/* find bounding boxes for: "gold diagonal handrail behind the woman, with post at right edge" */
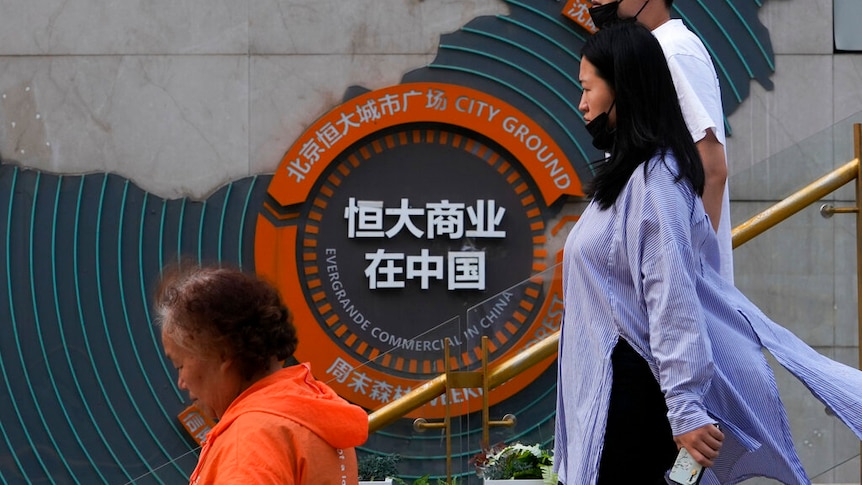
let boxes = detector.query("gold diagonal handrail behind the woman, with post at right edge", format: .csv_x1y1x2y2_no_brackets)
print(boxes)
368,123,862,474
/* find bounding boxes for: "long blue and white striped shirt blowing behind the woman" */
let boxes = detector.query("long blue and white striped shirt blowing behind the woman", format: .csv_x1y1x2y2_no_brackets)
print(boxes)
554,154,862,485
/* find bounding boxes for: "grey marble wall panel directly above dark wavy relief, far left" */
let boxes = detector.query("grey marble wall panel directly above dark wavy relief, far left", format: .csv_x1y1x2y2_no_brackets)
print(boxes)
0,56,248,198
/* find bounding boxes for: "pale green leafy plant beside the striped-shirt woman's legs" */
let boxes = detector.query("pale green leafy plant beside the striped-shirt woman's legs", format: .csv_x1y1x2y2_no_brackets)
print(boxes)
474,443,557,484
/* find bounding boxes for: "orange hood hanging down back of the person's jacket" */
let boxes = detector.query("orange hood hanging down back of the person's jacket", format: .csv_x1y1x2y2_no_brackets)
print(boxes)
213,363,368,448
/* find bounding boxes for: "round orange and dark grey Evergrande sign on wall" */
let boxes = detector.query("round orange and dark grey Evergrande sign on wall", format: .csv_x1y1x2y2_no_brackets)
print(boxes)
255,83,582,417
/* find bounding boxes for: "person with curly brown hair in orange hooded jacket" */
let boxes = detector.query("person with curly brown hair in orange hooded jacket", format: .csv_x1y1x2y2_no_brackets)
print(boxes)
155,266,368,485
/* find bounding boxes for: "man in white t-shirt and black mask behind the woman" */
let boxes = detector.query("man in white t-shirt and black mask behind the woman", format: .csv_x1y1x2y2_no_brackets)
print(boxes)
590,0,733,283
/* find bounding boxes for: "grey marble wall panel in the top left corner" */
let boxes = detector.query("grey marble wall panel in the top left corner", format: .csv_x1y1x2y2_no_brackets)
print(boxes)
0,0,249,55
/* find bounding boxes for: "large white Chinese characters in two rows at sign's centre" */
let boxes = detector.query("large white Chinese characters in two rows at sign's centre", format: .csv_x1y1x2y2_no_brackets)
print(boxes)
344,197,506,290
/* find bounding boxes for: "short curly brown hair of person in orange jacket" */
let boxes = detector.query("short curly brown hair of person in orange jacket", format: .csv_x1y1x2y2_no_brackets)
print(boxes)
154,264,298,379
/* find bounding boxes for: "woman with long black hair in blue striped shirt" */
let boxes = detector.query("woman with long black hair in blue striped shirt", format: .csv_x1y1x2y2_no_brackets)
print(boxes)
554,22,862,485
